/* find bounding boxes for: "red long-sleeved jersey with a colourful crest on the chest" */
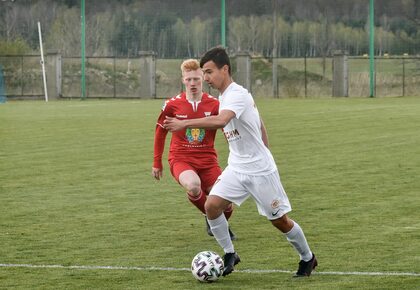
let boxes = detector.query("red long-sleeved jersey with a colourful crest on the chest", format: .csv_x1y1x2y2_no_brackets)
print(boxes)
153,92,219,168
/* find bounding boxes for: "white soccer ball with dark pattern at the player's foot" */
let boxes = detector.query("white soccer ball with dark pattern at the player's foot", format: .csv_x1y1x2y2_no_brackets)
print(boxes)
191,251,224,282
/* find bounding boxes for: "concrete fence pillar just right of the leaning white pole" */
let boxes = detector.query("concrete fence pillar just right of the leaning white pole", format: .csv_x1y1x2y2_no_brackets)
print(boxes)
45,50,62,100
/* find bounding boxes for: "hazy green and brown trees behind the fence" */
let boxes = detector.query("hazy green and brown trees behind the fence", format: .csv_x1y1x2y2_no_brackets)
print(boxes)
0,0,420,58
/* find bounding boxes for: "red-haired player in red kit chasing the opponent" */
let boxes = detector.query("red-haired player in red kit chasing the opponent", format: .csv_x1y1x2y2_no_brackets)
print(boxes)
152,59,235,239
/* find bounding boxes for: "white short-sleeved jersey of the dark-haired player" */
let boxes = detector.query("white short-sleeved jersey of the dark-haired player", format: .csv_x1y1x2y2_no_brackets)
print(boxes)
219,82,277,175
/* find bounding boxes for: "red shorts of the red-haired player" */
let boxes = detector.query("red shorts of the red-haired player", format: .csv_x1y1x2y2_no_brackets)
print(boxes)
169,160,222,194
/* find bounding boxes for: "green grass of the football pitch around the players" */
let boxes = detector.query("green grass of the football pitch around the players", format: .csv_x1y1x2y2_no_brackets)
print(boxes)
0,98,420,289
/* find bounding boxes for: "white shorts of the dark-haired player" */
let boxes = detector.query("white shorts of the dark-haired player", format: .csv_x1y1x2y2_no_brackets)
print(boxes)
210,166,292,220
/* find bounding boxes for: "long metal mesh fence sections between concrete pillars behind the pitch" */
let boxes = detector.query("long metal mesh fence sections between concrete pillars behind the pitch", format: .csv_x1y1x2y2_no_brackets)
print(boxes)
0,55,420,99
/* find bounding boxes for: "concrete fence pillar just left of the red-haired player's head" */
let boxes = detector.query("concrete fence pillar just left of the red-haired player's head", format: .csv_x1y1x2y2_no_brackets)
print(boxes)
139,51,156,98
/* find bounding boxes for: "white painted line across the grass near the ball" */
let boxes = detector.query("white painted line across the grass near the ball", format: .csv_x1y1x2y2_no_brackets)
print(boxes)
0,264,420,277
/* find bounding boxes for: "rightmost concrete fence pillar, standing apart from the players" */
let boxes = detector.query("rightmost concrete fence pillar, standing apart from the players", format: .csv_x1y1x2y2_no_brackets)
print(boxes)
332,50,349,97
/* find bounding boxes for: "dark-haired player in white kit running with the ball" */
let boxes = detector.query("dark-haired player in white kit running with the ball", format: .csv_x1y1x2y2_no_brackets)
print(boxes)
164,47,318,277
